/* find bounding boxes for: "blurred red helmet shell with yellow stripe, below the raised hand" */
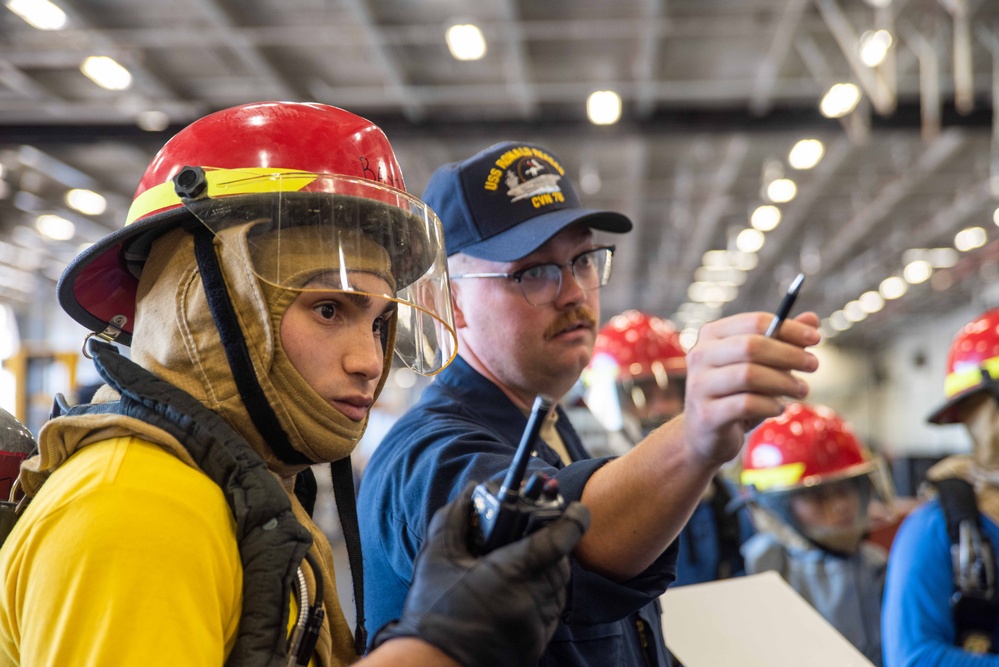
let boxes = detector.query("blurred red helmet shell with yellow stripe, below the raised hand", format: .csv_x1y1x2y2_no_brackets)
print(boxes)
742,403,875,493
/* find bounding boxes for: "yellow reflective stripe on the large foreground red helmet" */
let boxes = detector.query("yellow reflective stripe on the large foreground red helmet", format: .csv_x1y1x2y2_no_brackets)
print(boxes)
125,167,316,225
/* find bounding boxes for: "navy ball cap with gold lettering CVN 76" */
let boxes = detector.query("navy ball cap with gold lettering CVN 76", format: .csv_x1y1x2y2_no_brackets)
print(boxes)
423,141,632,262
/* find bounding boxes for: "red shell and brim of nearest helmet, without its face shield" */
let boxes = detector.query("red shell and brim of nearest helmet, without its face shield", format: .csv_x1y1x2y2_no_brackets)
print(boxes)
57,102,405,345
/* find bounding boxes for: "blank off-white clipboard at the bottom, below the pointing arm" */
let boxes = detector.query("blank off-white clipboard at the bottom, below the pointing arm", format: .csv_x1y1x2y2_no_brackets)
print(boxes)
661,572,873,667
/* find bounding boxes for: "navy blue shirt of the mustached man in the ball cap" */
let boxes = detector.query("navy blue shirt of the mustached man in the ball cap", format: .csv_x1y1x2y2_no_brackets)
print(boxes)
357,357,676,667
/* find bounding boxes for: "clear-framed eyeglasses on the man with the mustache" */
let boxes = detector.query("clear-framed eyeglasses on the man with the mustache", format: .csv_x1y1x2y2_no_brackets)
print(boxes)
451,246,614,306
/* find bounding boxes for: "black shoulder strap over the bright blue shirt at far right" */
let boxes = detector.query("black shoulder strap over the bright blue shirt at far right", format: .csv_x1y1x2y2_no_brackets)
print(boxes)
934,478,999,654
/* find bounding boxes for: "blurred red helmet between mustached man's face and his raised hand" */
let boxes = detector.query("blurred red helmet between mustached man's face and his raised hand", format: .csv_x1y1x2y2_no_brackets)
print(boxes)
590,310,687,378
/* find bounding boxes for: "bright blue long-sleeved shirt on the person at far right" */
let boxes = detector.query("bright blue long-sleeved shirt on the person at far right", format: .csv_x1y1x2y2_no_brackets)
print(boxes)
881,500,999,667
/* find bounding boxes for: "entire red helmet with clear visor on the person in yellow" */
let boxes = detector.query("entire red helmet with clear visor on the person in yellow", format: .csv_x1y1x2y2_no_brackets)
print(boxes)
57,102,456,372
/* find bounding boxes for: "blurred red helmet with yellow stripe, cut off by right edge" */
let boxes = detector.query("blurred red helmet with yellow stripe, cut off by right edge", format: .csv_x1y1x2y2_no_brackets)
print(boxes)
928,309,999,424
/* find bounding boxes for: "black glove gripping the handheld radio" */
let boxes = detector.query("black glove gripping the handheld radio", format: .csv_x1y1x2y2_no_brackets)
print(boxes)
373,484,590,667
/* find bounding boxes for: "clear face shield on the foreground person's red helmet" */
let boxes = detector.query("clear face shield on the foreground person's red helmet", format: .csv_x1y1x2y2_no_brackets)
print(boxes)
178,167,457,375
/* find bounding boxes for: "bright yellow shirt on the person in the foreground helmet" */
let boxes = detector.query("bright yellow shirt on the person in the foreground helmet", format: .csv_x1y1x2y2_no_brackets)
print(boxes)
0,437,243,667
